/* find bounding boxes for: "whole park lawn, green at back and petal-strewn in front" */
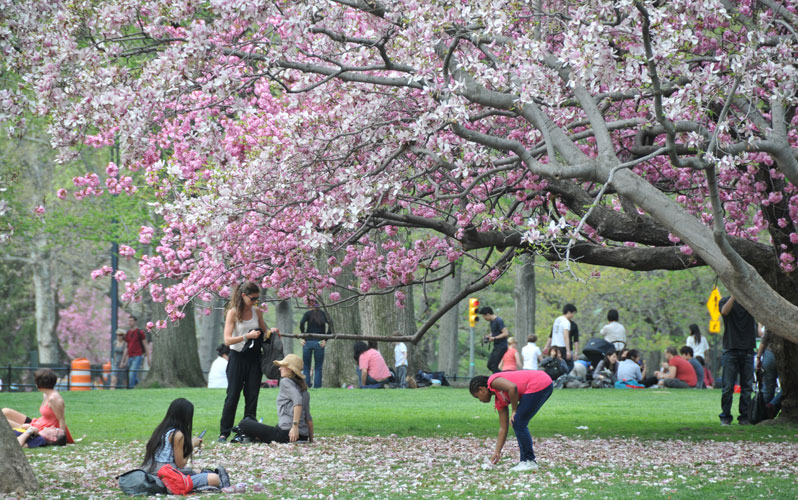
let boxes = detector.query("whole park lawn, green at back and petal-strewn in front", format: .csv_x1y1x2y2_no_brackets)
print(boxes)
6,388,798,499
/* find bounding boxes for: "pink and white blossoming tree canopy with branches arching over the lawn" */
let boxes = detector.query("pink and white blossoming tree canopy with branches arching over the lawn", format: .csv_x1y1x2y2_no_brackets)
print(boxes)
0,0,798,417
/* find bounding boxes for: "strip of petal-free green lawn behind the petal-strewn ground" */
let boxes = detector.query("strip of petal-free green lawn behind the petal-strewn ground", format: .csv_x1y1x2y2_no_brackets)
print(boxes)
0,387,798,441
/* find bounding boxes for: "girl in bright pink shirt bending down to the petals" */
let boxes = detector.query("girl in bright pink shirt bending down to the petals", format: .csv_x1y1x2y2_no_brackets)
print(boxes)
469,370,554,472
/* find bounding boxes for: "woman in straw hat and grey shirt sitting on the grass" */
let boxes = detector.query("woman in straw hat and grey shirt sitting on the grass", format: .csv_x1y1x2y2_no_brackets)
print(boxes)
238,354,313,443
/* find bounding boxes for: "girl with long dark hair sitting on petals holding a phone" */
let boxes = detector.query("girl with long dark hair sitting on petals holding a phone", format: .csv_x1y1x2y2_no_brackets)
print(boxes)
142,398,230,491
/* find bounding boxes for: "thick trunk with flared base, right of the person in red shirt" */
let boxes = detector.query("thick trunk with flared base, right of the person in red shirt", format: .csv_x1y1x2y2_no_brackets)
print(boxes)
143,294,206,387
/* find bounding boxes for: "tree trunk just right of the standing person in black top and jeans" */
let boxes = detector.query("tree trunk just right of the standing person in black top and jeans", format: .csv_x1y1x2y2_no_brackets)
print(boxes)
323,261,360,387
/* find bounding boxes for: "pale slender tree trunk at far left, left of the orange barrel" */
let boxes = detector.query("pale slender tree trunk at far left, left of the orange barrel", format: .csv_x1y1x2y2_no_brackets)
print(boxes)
30,233,62,364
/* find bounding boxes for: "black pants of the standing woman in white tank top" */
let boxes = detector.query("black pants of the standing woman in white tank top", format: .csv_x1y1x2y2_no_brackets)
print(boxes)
219,348,263,436
